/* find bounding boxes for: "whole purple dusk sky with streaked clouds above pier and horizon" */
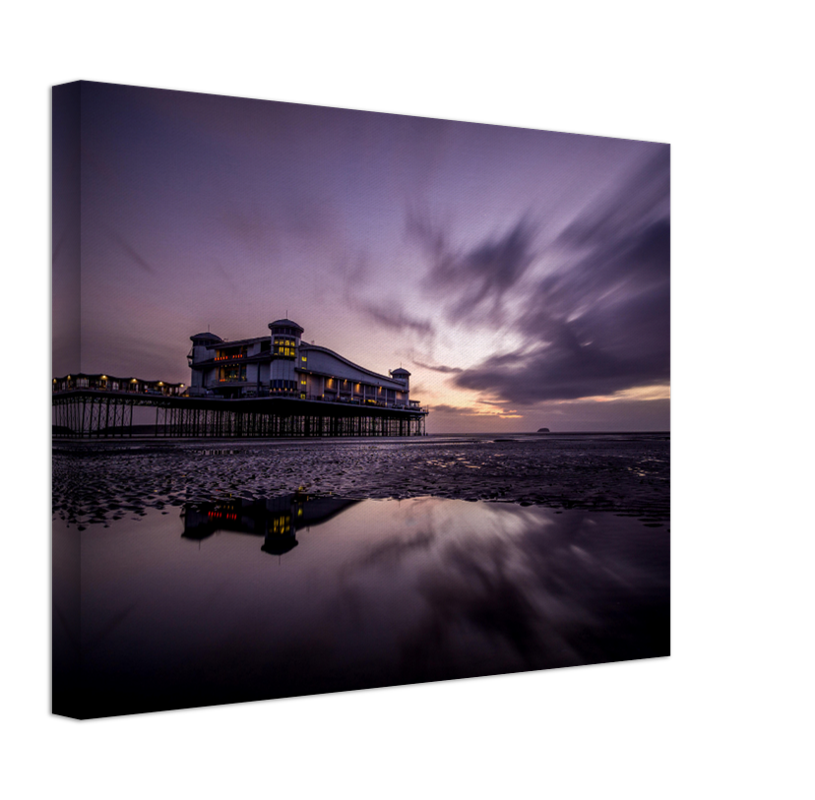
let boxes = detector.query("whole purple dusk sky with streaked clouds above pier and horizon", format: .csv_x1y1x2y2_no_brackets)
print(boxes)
52,81,671,433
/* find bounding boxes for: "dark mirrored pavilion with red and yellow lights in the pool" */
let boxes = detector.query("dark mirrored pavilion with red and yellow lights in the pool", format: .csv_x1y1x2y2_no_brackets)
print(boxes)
181,493,359,555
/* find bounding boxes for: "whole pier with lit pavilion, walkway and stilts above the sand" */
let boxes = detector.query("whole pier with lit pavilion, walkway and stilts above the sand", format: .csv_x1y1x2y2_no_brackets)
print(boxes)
51,319,428,438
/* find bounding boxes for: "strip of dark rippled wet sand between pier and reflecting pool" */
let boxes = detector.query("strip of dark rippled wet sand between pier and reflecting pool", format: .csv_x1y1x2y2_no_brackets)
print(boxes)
52,434,671,529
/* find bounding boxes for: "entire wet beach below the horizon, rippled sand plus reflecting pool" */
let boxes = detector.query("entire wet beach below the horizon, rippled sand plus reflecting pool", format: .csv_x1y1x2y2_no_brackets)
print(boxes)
51,432,672,698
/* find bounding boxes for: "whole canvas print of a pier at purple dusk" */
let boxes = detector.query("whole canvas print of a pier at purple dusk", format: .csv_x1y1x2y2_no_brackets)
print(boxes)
51,81,671,698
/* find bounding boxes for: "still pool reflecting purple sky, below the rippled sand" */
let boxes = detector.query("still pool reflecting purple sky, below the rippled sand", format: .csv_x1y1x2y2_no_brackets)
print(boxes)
68,495,671,694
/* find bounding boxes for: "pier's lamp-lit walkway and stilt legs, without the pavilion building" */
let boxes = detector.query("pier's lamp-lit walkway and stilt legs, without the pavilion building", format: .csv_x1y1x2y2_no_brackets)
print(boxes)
51,375,427,438
